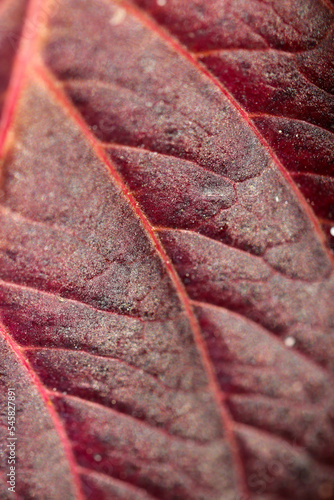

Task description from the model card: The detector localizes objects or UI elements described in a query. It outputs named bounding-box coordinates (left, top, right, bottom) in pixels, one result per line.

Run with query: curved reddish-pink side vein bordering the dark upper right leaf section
left=120, top=0, right=334, bottom=270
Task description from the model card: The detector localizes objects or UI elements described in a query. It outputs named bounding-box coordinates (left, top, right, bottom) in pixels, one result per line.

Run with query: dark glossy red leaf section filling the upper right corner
left=132, top=0, right=334, bottom=247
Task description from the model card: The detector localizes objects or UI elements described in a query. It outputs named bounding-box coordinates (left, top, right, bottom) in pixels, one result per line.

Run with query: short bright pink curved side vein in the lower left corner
left=0, top=323, right=84, bottom=500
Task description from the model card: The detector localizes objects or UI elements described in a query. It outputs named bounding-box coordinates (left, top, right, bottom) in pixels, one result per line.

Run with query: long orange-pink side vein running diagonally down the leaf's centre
left=35, top=64, right=249, bottom=499
